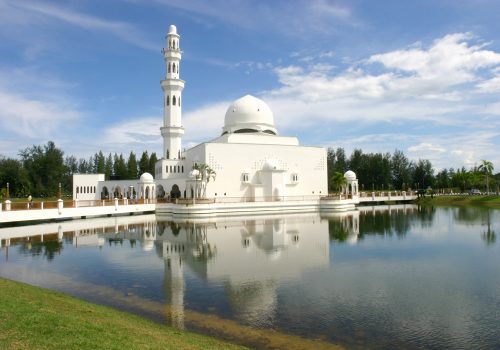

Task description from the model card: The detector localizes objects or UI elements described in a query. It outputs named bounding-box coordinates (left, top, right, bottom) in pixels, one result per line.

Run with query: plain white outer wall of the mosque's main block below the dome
left=185, top=139, right=328, bottom=198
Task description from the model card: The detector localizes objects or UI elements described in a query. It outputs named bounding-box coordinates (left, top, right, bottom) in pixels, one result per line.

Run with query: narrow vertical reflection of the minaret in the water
left=163, top=242, right=185, bottom=329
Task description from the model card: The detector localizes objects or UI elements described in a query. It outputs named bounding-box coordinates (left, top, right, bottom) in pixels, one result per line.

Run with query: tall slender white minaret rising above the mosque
left=160, top=25, right=184, bottom=159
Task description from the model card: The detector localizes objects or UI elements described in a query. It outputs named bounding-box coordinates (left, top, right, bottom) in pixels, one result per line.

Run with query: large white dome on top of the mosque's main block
left=222, top=95, right=278, bottom=135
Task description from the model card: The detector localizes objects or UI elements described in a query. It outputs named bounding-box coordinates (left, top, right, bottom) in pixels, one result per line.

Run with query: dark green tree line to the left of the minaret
left=0, top=141, right=158, bottom=198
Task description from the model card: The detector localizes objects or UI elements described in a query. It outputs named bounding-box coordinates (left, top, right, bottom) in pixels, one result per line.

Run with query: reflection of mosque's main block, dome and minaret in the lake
left=155, top=214, right=329, bottom=327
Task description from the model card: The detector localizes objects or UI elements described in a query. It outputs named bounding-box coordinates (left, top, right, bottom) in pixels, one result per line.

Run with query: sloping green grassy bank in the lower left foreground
left=0, top=278, right=241, bottom=349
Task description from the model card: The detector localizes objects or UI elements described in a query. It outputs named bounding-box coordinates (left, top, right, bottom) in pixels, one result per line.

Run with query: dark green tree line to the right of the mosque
left=327, top=147, right=500, bottom=192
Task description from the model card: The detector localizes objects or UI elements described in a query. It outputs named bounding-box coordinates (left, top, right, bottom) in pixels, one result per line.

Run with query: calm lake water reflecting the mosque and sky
left=0, top=205, right=500, bottom=349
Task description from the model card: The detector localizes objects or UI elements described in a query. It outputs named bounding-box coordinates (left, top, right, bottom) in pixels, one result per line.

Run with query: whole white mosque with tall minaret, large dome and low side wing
left=73, top=25, right=357, bottom=208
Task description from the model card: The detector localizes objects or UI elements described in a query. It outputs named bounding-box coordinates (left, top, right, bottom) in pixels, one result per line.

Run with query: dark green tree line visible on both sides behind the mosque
left=0, top=141, right=500, bottom=198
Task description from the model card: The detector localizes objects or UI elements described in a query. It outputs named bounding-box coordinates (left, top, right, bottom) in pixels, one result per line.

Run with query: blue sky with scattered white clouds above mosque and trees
left=0, top=0, right=500, bottom=172
